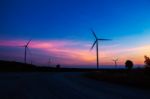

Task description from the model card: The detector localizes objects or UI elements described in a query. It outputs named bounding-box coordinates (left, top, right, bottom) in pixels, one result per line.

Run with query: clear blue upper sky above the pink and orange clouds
left=0, top=0, right=150, bottom=67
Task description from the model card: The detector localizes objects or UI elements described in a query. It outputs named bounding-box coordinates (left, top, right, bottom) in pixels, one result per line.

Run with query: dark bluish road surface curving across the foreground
left=0, top=72, right=150, bottom=99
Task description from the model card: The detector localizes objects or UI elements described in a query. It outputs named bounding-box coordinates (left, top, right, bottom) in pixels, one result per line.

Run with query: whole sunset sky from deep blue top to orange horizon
left=0, top=0, right=150, bottom=67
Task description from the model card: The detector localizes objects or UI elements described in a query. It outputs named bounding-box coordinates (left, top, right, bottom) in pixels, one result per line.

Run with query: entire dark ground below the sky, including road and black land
left=0, top=61, right=150, bottom=99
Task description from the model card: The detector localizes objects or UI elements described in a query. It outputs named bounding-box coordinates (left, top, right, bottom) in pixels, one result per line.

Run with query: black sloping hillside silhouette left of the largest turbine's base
left=0, top=60, right=99, bottom=72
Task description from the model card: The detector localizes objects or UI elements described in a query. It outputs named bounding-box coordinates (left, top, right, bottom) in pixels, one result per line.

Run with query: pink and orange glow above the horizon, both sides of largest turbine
left=0, top=40, right=150, bottom=65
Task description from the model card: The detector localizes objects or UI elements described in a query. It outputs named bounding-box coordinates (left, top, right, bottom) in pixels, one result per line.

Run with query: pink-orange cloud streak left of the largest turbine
left=0, top=40, right=94, bottom=65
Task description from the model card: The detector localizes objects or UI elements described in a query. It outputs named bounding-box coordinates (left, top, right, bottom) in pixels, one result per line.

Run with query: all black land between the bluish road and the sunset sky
left=0, top=61, right=150, bottom=90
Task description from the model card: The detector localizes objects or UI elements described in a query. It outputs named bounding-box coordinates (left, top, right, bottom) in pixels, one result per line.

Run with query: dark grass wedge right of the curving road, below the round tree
left=84, top=69, right=150, bottom=90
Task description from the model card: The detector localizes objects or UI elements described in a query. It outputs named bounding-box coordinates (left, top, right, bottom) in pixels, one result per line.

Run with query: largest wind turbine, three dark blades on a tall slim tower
left=91, top=29, right=111, bottom=69
